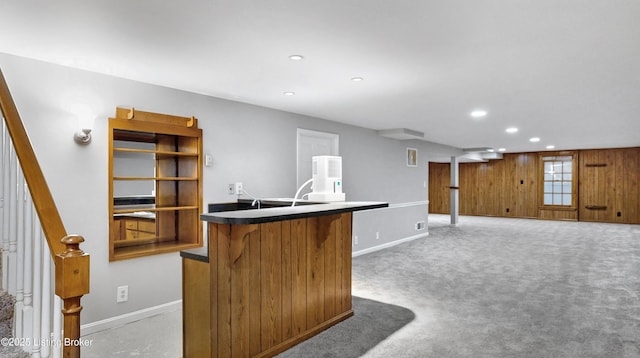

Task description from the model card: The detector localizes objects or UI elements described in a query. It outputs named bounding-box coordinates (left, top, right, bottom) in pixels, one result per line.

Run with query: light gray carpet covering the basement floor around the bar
left=83, top=215, right=640, bottom=358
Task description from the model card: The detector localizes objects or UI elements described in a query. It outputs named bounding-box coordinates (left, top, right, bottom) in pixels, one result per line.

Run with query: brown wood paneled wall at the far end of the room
left=429, top=148, right=640, bottom=224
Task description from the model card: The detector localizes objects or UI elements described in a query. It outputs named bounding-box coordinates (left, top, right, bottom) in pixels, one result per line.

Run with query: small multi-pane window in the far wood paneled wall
left=541, top=155, right=576, bottom=207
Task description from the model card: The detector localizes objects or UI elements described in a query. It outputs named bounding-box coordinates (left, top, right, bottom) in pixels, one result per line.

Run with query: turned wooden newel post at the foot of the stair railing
left=54, top=235, right=89, bottom=357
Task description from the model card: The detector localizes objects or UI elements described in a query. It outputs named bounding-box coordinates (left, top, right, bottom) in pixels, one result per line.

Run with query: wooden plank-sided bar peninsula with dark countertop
left=181, top=200, right=388, bottom=358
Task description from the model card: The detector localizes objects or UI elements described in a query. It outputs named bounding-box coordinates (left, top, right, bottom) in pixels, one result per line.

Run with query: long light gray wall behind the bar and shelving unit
left=0, top=54, right=459, bottom=324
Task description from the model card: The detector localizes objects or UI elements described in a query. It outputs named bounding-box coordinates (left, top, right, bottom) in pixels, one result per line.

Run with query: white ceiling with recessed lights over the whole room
left=0, top=0, right=640, bottom=152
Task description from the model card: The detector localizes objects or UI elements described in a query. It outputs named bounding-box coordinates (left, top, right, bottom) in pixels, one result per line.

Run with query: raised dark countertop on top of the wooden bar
left=200, top=201, right=389, bottom=225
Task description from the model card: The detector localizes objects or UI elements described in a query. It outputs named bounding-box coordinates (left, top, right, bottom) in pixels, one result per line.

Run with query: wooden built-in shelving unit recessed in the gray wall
left=109, top=108, right=203, bottom=261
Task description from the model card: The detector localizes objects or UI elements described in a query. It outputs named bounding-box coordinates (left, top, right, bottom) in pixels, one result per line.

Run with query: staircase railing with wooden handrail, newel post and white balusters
left=0, top=71, right=89, bottom=357
